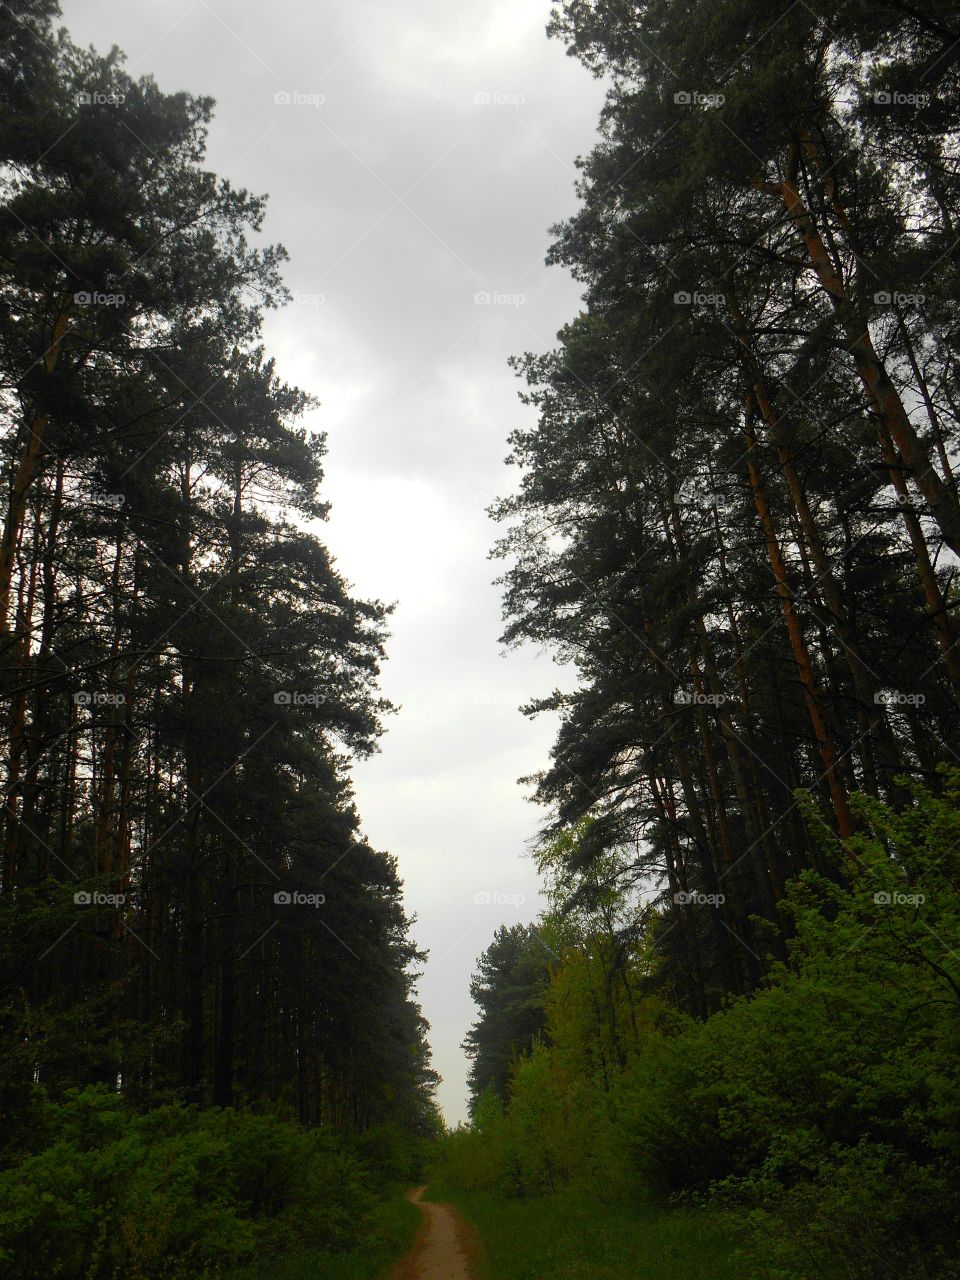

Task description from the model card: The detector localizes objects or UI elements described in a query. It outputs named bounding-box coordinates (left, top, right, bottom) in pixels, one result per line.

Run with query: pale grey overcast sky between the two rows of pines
left=63, top=0, right=602, bottom=1123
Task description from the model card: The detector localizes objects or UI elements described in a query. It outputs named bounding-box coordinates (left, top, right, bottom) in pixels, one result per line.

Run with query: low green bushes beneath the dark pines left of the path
left=0, top=1087, right=394, bottom=1280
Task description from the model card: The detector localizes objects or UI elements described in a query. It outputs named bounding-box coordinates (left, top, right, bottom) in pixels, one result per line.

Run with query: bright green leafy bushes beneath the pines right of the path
left=442, top=771, right=960, bottom=1280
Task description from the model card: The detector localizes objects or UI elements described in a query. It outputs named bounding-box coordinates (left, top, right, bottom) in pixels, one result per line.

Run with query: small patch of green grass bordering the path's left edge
left=236, top=1188, right=420, bottom=1280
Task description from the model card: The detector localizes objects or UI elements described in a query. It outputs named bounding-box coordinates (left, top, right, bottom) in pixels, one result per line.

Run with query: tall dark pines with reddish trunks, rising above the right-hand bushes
left=495, top=0, right=960, bottom=1016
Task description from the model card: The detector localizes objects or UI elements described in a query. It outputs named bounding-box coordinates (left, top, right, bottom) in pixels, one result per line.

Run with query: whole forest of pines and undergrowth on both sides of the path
left=0, top=0, right=960, bottom=1280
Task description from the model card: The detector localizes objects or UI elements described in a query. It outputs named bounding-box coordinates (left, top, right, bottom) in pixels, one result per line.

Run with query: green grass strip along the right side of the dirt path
left=428, top=1184, right=765, bottom=1280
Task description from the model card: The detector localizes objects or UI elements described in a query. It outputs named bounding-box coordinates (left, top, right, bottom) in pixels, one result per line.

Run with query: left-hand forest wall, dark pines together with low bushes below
left=0, top=0, right=436, bottom=1277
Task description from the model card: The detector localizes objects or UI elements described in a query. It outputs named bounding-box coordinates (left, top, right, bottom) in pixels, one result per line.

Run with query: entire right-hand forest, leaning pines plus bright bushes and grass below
left=438, top=0, right=960, bottom=1280
